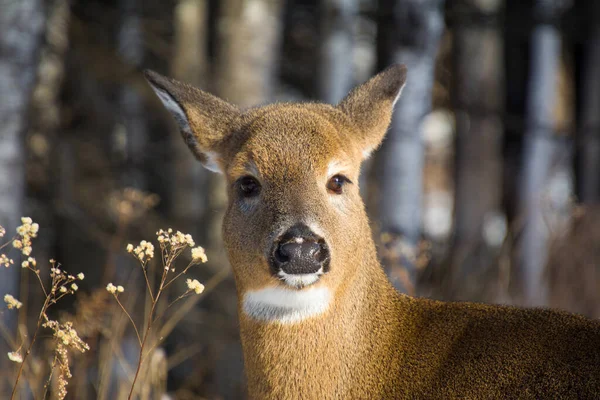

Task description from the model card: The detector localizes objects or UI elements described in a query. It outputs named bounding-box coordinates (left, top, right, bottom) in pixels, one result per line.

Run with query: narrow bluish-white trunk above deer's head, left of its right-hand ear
left=318, top=0, right=358, bottom=104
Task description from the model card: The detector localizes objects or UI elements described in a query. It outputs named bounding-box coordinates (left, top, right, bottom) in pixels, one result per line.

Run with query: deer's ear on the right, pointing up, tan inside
left=337, top=64, right=406, bottom=158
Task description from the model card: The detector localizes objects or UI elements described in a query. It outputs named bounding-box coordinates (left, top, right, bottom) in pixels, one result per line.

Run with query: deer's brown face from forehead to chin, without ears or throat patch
left=223, top=105, right=366, bottom=290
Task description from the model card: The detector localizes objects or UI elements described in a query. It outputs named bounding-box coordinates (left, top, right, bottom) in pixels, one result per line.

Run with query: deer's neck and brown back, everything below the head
left=240, top=239, right=600, bottom=399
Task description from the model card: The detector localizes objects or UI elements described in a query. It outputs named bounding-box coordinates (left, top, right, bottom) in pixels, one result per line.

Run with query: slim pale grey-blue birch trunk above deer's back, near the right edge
left=519, top=0, right=567, bottom=306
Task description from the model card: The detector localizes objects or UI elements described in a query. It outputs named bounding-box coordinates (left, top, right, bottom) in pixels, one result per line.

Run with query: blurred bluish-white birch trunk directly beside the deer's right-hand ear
left=375, top=0, right=444, bottom=293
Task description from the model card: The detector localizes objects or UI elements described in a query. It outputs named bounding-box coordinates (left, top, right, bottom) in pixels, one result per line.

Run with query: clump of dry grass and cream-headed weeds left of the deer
left=0, top=193, right=227, bottom=399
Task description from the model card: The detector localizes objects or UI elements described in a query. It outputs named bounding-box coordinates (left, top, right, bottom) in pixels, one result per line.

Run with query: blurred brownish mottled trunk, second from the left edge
left=24, top=0, right=71, bottom=354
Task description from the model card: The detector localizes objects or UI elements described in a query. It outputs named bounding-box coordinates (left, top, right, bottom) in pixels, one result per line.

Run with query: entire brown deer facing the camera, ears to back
left=145, top=65, right=600, bottom=399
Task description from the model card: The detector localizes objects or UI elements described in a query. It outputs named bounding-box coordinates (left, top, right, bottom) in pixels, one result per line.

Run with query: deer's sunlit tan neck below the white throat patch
left=240, top=245, right=403, bottom=399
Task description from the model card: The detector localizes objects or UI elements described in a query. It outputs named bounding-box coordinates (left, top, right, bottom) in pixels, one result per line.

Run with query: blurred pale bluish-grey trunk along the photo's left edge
left=0, top=0, right=44, bottom=334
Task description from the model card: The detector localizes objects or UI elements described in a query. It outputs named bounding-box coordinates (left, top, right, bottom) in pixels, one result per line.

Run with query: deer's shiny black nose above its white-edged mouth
left=271, top=224, right=329, bottom=274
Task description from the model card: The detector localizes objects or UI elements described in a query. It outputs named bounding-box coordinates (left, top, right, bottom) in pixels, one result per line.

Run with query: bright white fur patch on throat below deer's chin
left=242, top=286, right=331, bottom=324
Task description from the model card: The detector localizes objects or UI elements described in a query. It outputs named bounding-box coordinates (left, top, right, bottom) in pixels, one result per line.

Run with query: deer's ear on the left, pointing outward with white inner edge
left=144, top=70, right=240, bottom=172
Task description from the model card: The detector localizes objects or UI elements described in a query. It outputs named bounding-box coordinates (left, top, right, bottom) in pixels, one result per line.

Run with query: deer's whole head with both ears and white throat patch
left=148, top=66, right=405, bottom=322
